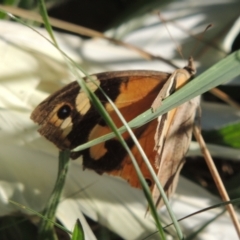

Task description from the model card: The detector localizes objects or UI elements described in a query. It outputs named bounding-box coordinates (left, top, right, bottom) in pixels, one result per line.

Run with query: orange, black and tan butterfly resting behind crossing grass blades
left=31, top=59, right=198, bottom=207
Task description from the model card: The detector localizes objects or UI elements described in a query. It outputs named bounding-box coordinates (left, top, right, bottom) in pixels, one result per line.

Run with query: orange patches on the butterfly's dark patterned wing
left=89, top=77, right=163, bottom=188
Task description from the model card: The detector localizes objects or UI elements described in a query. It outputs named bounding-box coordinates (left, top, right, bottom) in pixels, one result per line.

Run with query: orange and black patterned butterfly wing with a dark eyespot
left=31, top=71, right=169, bottom=187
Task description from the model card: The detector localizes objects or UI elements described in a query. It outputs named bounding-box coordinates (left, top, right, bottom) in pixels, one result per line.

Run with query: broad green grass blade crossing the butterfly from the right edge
left=73, top=50, right=240, bottom=151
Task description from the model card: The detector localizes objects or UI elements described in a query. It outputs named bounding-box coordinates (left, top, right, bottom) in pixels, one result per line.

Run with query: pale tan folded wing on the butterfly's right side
left=152, top=62, right=199, bottom=207
